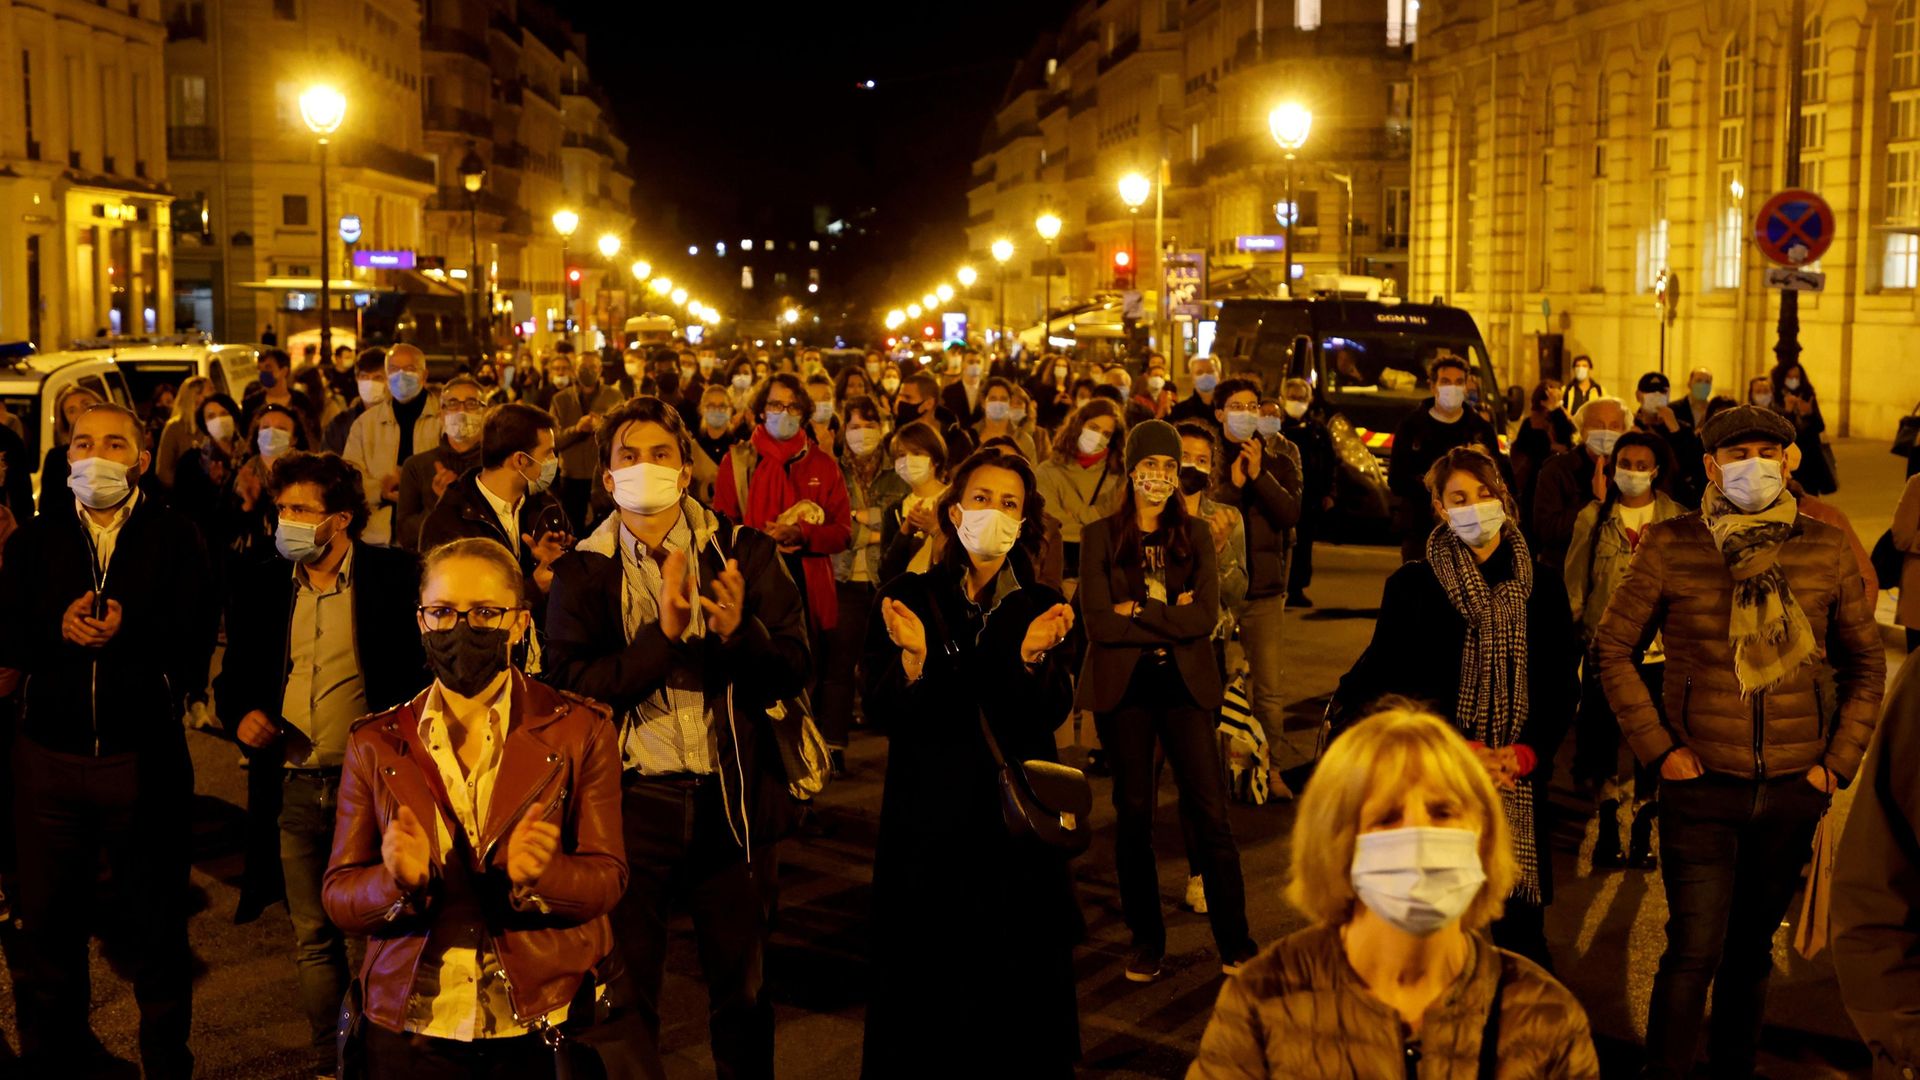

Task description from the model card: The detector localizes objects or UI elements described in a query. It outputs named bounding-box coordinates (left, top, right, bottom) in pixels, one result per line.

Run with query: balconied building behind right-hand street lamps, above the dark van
left=968, top=0, right=1417, bottom=345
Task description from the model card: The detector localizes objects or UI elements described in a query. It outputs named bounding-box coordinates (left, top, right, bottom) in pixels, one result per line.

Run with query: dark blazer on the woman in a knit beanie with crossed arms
left=1075, top=505, right=1221, bottom=713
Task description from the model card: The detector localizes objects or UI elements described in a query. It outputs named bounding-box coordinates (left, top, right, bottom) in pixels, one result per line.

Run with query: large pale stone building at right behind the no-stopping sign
left=1411, top=0, right=1920, bottom=436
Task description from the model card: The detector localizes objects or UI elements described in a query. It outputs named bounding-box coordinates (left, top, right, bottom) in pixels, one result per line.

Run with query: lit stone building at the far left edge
left=0, top=0, right=173, bottom=350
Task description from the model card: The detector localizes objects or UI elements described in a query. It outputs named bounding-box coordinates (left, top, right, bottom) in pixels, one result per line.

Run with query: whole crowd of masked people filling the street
left=0, top=330, right=1920, bottom=1078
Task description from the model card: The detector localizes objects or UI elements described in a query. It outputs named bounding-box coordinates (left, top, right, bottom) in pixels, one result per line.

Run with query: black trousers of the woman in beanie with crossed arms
left=1094, top=657, right=1252, bottom=959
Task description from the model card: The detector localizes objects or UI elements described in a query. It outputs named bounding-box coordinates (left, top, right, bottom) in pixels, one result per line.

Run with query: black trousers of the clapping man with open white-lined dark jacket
left=612, top=773, right=774, bottom=1080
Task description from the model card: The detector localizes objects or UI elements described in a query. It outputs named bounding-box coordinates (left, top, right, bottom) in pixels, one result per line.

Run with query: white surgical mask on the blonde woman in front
left=1348, top=826, right=1486, bottom=938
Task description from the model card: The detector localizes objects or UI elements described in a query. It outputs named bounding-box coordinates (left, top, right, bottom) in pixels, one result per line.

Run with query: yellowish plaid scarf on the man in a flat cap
left=1699, top=486, right=1814, bottom=698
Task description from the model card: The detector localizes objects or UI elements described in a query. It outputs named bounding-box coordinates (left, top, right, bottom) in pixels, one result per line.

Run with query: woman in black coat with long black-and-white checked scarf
left=1329, top=446, right=1578, bottom=970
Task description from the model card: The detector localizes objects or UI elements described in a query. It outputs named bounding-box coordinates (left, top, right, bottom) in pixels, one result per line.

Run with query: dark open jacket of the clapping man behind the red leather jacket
left=541, top=503, right=812, bottom=849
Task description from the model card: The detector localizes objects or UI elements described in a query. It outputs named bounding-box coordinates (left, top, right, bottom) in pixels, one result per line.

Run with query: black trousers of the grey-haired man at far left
left=10, top=717, right=194, bottom=1078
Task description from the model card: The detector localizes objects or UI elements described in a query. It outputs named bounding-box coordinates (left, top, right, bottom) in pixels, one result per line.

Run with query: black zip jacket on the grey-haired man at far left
left=0, top=494, right=219, bottom=755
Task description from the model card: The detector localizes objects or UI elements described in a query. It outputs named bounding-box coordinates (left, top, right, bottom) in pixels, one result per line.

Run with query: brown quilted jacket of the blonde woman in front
left=1187, top=926, right=1599, bottom=1080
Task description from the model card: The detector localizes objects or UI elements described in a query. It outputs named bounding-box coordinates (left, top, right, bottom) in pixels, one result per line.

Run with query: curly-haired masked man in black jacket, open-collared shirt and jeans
left=213, top=452, right=426, bottom=1072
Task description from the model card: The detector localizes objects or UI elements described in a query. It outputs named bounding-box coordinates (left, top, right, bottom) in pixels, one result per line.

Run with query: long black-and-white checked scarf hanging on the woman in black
left=1427, top=523, right=1540, bottom=905
